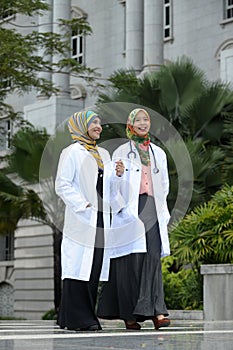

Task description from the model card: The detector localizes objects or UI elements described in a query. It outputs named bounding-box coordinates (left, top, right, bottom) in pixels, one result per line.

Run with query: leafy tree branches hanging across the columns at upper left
left=0, top=0, right=95, bottom=114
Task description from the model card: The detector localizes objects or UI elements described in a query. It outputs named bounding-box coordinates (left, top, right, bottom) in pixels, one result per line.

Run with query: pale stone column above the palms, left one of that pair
left=126, top=0, right=143, bottom=72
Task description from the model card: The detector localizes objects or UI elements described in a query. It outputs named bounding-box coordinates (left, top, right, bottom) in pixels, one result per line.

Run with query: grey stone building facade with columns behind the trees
left=0, top=0, right=233, bottom=318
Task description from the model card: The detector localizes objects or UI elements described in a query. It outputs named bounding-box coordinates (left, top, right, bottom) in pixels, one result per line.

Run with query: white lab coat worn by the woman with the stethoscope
left=110, top=142, right=170, bottom=258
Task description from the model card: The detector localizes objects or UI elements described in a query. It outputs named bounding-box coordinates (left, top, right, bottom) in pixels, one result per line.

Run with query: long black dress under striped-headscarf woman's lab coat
left=57, top=171, right=104, bottom=330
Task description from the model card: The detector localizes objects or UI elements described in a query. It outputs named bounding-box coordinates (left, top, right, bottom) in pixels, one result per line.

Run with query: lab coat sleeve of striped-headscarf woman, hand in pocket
left=55, top=150, right=89, bottom=212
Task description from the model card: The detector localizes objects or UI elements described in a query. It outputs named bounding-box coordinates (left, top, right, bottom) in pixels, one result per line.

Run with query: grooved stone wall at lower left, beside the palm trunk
left=14, top=220, right=54, bottom=319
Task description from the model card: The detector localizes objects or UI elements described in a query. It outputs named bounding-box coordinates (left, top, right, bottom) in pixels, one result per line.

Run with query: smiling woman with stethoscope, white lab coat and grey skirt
left=97, top=109, right=170, bottom=330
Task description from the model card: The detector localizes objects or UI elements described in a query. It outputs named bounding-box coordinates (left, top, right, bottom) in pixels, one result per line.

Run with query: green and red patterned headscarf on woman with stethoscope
left=126, top=108, right=150, bottom=166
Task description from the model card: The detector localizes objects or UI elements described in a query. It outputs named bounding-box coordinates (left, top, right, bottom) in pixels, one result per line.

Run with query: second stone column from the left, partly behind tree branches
left=53, top=0, right=71, bottom=97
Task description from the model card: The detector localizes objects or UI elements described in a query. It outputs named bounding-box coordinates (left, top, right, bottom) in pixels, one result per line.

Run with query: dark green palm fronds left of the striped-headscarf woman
left=0, top=126, right=51, bottom=234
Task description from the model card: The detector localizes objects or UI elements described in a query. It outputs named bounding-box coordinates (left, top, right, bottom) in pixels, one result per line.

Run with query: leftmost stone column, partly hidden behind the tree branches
left=37, top=0, right=53, bottom=100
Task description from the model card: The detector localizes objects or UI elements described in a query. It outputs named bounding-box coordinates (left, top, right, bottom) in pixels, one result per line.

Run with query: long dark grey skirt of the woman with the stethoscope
left=97, top=194, right=168, bottom=322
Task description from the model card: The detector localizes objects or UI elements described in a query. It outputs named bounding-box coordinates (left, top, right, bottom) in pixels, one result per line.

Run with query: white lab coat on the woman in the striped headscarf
left=55, top=142, right=111, bottom=281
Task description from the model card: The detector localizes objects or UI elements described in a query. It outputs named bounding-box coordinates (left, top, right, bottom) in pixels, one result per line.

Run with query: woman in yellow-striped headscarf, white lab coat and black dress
left=55, top=111, right=110, bottom=331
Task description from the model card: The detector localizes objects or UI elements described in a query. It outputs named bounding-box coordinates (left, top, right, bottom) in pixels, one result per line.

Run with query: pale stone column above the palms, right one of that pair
left=143, top=0, right=163, bottom=73
